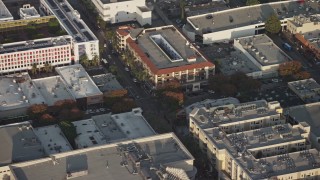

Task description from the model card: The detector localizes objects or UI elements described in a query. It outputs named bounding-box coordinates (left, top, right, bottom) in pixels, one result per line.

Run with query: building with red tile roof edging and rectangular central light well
left=122, top=25, right=215, bottom=91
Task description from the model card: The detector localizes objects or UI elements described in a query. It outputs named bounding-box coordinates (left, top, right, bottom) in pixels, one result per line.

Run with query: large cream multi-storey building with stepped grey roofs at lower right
left=189, top=100, right=320, bottom=180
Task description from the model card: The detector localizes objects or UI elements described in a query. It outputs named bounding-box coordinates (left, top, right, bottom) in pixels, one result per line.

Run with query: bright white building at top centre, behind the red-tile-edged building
left=92, top=0, right=152, bottom=26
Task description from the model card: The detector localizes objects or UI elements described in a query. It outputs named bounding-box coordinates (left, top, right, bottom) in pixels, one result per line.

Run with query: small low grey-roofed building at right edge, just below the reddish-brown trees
left=288, top=78, right=320, bottom=103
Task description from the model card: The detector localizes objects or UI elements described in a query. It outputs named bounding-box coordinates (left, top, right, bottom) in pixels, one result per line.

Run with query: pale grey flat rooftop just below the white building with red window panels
left=56, top=64, right=102, bottom=99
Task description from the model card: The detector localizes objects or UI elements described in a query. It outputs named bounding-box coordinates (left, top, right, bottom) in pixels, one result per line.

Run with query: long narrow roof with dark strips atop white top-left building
left=45, top=0, right=98, bottom=42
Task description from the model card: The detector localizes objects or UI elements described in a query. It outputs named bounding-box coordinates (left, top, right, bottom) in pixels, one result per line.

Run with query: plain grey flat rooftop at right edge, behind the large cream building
left=288, top=102, right=320, bottom=137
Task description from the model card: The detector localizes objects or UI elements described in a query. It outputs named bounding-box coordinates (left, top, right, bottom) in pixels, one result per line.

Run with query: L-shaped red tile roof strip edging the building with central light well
left=126, top=38, right=214, bottom=75
